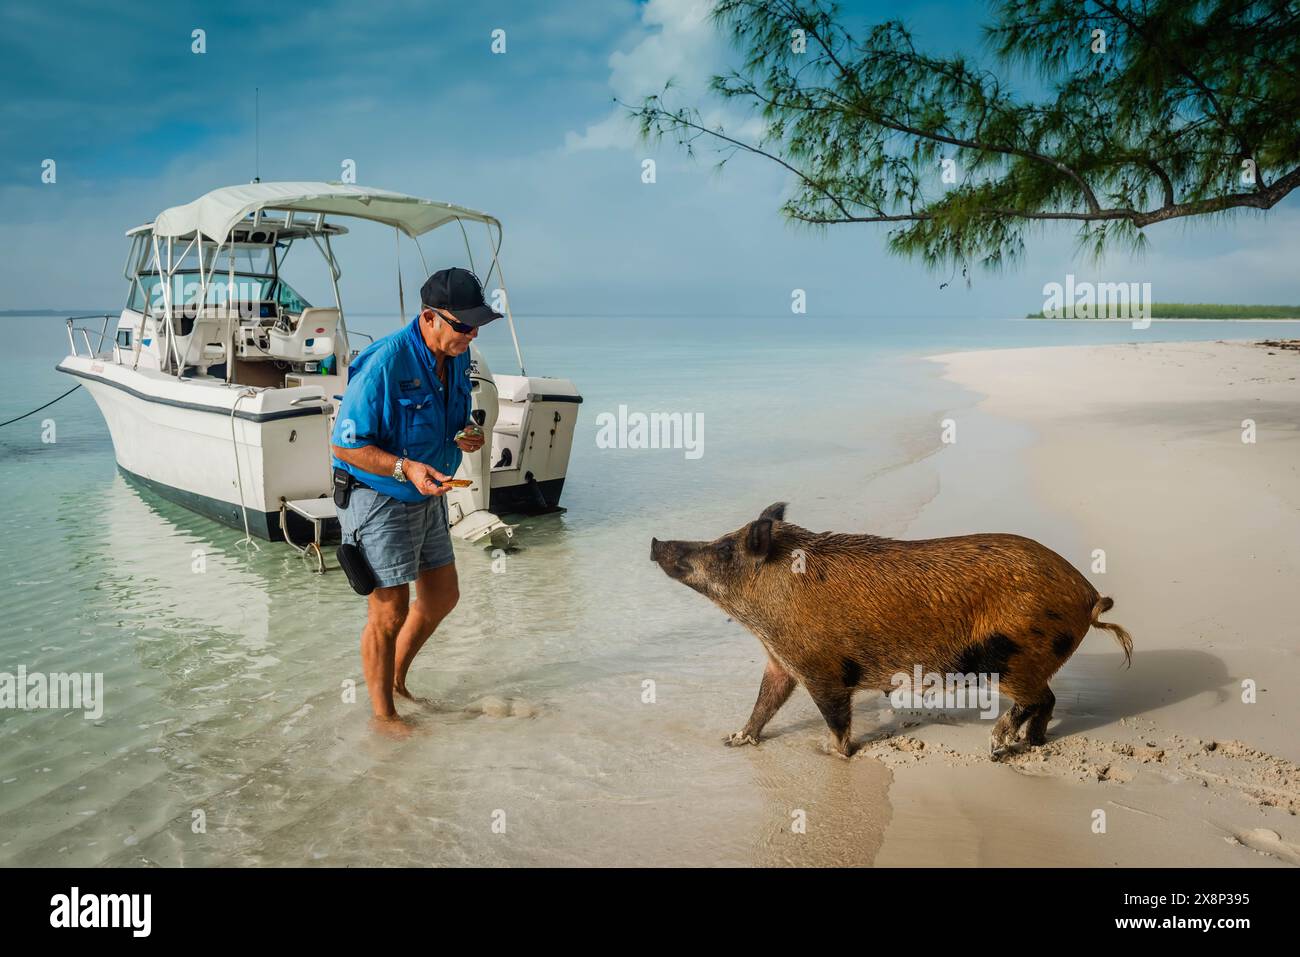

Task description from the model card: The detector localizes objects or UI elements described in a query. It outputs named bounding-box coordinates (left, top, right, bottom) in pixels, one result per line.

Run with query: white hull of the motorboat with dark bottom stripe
left=57, top=356, right=582, bottom=544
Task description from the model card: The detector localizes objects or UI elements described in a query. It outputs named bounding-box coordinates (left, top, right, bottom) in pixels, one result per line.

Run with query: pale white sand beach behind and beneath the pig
left=858, top=342, right=1300, bottom=866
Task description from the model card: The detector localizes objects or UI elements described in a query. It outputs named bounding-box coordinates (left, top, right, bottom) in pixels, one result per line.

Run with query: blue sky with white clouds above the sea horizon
left=0, top=0, right=1300, bottom=321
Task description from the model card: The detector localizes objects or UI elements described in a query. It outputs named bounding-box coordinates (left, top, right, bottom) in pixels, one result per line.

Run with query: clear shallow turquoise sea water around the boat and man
left=0, top=317, right=1300, bottom=865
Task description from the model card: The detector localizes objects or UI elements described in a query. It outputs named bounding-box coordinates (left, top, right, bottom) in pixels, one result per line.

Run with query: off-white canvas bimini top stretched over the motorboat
left=148, top=183, right=501, bottom=242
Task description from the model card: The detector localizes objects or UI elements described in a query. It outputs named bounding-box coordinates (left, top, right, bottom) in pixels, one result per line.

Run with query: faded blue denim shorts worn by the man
left=338, top=488, right=456, bottom=588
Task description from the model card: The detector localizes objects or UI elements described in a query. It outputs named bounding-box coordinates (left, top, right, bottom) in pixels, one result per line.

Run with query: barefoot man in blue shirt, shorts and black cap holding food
left=332, top=269, right=501, bottom=727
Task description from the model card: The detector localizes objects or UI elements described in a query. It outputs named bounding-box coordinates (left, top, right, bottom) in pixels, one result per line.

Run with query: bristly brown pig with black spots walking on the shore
left=650, top=502, right=1132, bottom=757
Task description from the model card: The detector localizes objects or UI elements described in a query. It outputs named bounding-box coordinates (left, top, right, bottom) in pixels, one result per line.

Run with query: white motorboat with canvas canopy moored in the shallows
left=57, top=182, right=582, bottom=568
